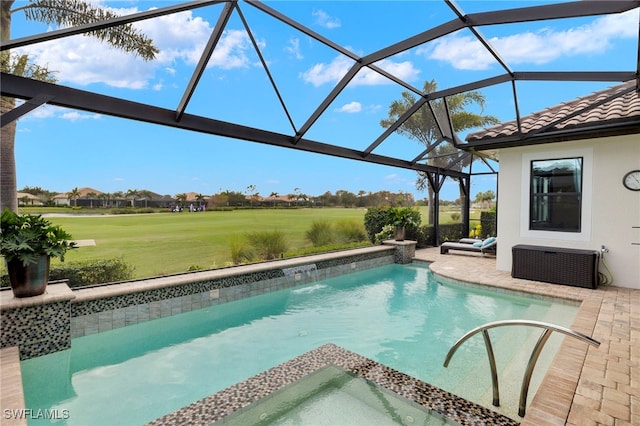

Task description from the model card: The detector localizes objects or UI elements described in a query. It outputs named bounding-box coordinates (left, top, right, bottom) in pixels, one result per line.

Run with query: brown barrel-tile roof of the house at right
left=466, top=80, right=640, bottom=148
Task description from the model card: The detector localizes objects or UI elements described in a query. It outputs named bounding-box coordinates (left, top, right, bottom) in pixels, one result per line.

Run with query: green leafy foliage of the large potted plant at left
left=0, top=209, right=76, bottom=266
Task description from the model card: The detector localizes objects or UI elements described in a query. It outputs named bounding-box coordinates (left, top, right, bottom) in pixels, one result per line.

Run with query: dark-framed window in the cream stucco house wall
left=529, top=157, right=583, bottom=232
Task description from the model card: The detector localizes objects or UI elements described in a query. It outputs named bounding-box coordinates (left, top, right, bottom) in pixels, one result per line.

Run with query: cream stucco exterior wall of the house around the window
left=497, top=135, right=640, bottom=288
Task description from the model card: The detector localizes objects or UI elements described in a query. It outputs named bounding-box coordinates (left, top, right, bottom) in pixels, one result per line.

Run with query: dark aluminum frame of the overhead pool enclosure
left=0, top=0, right=640, bottom=243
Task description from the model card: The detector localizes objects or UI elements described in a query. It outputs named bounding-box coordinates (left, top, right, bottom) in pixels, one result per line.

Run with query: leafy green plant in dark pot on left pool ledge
left=0, top=209, right=76, bottom=297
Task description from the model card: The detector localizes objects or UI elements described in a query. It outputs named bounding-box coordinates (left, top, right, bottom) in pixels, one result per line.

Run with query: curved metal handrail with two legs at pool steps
left=444, top=320, right=600, bottom=417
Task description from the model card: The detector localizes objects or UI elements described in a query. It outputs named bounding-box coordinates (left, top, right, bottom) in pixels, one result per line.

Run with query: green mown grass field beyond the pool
left=5, top=207, right=479, bottom=278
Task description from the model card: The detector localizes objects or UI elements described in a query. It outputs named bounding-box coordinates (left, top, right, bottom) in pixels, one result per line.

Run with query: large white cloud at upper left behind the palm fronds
left=21, top=9, right=253, bottom=89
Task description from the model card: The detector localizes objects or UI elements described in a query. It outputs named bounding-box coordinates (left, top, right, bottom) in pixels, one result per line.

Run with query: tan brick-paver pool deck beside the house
left=416, top=248, right=640, bottom=426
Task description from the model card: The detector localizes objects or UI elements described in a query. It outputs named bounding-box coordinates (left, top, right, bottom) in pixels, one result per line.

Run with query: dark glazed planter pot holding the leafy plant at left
left=7, top=255, right=50, bottom=297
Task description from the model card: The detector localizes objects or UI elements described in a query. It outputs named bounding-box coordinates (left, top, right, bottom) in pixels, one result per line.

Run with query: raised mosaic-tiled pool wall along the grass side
left=0, top=249, right=394, bottom=360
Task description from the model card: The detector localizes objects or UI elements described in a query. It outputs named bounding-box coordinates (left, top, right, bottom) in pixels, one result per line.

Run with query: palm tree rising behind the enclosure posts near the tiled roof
left=380, top=80, right=499, bottom=223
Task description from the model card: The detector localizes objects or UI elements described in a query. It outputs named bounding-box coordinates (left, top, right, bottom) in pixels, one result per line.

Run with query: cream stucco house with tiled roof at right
left=466, top=81, right=640, bottom=289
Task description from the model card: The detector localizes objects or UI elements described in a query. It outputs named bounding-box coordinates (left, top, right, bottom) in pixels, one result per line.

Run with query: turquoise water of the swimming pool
left=21, top=265, right=577, bottom=425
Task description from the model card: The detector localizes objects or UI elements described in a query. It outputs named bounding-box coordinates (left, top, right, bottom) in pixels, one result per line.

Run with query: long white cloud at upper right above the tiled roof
left=418, top=10, right=638, bottom=70
